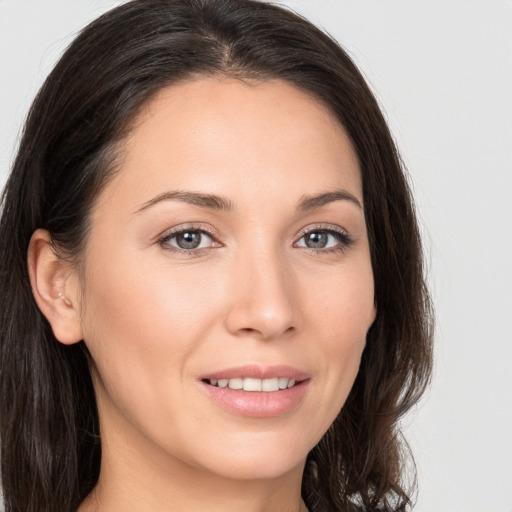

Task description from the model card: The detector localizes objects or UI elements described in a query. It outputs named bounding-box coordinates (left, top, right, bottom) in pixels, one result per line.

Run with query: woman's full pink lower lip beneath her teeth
left=201, top=380, right=309, bottom=418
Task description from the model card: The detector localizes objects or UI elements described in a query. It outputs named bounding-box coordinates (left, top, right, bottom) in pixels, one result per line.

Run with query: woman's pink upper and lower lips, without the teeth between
left=201, top=365, right=310, bottom=418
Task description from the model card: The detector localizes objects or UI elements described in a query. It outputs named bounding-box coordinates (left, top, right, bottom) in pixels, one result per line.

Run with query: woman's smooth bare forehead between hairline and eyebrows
left=94, top=78, right=362, bottom=216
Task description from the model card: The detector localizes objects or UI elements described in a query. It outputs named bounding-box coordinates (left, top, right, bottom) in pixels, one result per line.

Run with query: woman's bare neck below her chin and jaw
left=78, top=400, right=307, bottom=512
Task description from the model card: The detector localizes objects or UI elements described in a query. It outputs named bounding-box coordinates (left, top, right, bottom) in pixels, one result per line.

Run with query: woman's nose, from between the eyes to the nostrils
left=226, top=247, right=299, bottom=340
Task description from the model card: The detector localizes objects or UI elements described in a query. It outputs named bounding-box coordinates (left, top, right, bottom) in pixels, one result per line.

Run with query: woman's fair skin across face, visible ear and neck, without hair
left=29, top=78, right=375, bottom=512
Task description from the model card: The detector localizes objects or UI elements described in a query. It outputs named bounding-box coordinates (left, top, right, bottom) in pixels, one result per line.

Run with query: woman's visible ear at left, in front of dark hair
left=27, top=229, right=82, bottom=345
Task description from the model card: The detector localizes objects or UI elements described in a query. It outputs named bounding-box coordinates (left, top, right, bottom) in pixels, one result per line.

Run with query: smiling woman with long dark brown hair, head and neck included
left=0, top=0, right=431, bottom=512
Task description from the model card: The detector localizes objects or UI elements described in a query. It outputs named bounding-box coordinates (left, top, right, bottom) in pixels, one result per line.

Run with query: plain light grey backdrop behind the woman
left=0, top=0, right=512, bottom=512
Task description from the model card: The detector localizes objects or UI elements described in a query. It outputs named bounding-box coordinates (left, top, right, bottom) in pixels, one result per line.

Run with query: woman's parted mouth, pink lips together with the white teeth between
left=201, top=365, right=310, bottom=418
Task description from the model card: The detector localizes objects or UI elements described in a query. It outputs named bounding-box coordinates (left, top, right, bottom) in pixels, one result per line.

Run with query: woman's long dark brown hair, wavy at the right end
left=0, top=0, right=432, bottom=512
